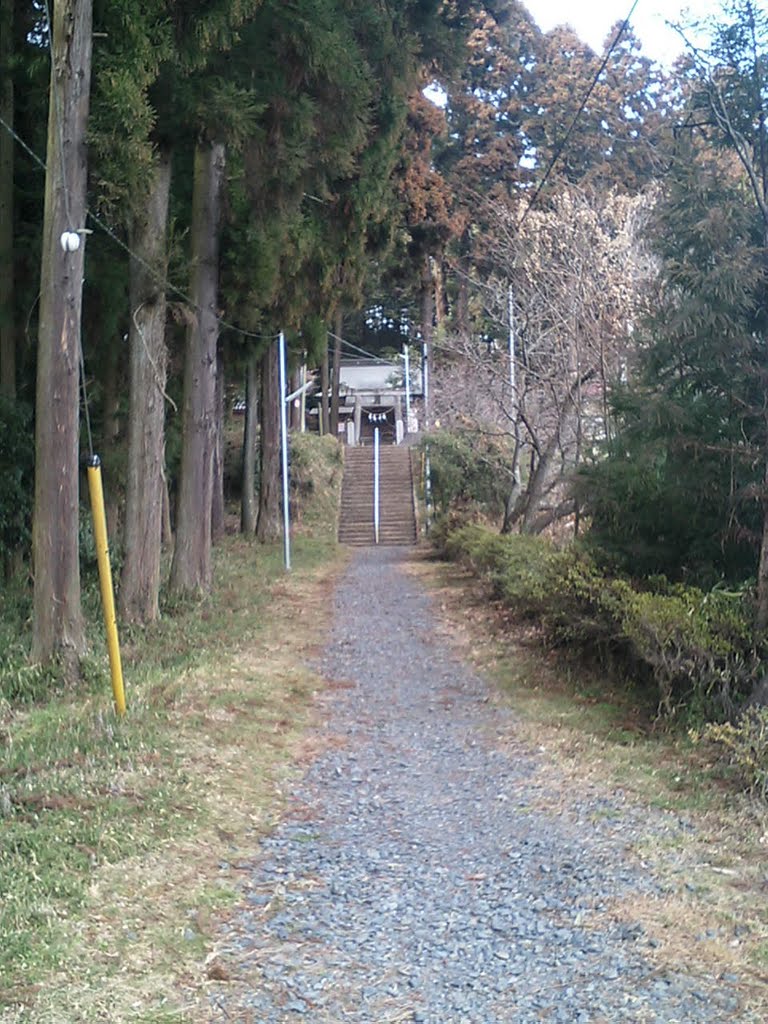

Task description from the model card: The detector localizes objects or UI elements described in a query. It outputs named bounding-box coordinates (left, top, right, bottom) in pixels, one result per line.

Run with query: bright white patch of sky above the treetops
left=523, top=0, right=719, bottom=65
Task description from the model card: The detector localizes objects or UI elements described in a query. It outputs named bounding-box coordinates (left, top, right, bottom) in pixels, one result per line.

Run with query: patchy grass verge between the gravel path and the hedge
left=412, top=556, right=768, bottom=1020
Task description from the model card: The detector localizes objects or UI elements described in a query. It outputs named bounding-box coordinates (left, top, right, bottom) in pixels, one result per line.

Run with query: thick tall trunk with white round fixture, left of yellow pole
left=32, top=0, right=92, bottom=675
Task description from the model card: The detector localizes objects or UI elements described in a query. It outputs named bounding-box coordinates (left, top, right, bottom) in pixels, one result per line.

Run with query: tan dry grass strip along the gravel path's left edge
left=0, top=558, right=348, bottom=1024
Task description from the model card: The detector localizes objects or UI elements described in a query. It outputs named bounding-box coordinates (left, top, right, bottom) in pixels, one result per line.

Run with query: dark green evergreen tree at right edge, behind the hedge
left=578, top=140, right=768, bottom=585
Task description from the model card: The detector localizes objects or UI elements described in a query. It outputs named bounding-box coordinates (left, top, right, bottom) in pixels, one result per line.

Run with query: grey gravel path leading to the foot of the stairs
left=211, top=549, right=752, bottom=1024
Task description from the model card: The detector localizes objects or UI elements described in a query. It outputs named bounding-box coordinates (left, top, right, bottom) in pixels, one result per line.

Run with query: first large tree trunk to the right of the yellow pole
left=120, top=154, right=171, bottom=623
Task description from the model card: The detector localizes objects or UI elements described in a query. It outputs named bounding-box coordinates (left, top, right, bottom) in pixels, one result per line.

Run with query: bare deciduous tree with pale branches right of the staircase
left=435, top=187, right=652, bottom=532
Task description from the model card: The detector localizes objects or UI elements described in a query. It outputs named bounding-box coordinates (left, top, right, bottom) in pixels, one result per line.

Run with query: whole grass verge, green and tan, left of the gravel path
left=0, top=537, right=342, bottom=1024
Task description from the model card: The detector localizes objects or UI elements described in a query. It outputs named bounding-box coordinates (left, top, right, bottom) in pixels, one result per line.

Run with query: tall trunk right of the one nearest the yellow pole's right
left=170, top=142, right=224, bottom=594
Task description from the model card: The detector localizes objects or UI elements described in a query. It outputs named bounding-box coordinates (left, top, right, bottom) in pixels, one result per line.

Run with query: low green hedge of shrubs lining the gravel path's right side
left=433, top=524, right=764, bottom=721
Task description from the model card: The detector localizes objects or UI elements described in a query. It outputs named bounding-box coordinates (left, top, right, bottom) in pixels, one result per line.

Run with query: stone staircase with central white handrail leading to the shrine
left=339, top=444, right=417, bottom=546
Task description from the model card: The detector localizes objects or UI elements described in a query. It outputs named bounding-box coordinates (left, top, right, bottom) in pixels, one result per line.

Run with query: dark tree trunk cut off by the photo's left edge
left=0, top=0, right=16, bottom=401
